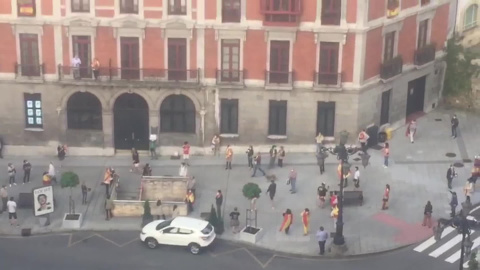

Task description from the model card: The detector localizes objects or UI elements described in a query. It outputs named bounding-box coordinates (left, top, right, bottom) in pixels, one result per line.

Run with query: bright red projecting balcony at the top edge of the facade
left=260, top=0, right=302, bottom=26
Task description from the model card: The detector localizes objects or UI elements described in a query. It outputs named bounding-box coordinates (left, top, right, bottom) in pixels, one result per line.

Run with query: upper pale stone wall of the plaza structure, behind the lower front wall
left=141, top=176, right=188, bottom=202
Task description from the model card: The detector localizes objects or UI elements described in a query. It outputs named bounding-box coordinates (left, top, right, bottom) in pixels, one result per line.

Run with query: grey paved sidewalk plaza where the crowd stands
left=0, top=106, right=480, bottom=255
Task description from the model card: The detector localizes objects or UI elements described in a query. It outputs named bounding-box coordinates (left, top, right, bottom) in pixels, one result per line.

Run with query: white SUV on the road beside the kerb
left=140, top=217, right=216, bottom=255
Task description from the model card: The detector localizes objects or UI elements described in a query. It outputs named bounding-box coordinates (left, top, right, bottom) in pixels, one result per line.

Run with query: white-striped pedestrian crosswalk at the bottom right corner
left=413, top=227, right=480, bottom=267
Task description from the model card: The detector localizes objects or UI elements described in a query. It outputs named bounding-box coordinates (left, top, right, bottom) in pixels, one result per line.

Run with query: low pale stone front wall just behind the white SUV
left=112, top=200, right=188, bottom=217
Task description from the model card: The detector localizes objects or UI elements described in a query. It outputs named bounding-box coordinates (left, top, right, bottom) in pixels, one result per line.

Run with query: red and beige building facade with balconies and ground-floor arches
left=0, top=0, right=452, bottom=155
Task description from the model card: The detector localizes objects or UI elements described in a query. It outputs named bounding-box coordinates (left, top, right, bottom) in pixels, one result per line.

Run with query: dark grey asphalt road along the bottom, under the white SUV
left=0, top=232, right=455, bottom=270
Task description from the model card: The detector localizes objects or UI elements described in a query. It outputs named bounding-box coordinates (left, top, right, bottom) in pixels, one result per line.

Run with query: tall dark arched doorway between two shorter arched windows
left=113, top=93, right=149, bottom=150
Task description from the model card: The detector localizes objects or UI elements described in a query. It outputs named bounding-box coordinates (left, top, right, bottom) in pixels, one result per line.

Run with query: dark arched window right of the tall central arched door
left=160, top=95, right=195, bottom=133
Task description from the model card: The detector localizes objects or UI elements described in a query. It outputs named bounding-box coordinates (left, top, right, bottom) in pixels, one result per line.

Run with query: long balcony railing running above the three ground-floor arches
left=58, top=65, right=200, bottom=84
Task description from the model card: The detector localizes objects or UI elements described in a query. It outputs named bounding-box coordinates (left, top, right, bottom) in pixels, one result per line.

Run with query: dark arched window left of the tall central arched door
left=67, top=92, right=103, bottom=130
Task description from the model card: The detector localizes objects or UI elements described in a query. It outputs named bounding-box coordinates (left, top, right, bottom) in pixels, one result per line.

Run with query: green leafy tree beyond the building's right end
left=444, top=37, right=479, bottom=96
